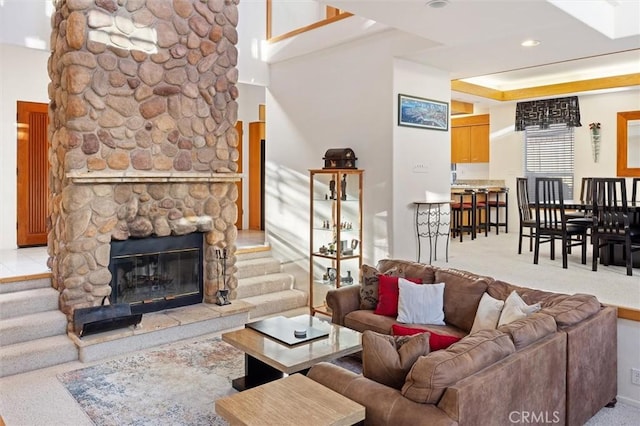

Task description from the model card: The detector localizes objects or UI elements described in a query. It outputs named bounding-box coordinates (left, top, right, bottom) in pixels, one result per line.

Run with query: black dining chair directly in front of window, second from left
left=533, top=177, right=589, bottom=269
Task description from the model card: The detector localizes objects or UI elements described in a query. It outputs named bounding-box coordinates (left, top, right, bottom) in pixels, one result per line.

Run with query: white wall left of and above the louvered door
left=0, top=44, right=49, bottom=249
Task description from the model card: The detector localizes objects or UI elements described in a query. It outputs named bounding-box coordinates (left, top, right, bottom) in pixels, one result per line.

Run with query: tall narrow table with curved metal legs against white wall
left=413, top=200, right=451, bottom=264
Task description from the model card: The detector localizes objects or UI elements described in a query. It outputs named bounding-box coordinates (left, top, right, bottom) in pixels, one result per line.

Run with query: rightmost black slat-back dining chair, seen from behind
left=591, top=178, right=640, bottom=276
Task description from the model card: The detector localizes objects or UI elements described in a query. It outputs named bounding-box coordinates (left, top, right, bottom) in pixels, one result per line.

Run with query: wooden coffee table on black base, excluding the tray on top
left=222, top=315, right=362, bottom=391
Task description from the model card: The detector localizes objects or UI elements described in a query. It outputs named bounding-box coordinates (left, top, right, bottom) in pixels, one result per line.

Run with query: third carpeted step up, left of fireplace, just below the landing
left=0, top=287, right=58, bottom=319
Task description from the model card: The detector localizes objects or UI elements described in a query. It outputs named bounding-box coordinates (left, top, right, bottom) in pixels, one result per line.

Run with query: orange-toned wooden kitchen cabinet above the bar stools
left=451, top=114, right=489, bottom=163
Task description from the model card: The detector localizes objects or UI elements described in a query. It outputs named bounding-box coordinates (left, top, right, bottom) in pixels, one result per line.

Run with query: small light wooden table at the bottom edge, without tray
left=216, top=374, right=365, bottom=426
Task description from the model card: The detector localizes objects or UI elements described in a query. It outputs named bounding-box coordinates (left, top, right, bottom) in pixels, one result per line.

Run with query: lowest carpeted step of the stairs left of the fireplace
left=0, top=335, right=78, bottom=377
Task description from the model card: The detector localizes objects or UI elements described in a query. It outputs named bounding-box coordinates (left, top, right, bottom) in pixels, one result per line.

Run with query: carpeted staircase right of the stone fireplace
left=236, top=247, right=307, bottom=319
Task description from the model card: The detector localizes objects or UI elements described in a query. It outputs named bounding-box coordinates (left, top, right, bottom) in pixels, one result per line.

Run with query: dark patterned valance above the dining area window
left=516, top=96, right=582, bottom=131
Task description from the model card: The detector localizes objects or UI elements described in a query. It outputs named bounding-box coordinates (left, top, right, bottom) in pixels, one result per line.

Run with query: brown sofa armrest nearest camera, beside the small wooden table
left=307, top=362, right=457, bottom=426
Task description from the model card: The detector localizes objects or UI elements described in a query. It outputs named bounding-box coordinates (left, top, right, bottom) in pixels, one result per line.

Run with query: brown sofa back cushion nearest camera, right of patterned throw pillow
left=402, top=330, right=515, bottom=404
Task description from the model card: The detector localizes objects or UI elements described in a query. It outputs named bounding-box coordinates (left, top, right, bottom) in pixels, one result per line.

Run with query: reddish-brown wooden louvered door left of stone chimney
left=17, top=101, right=49, bottom=247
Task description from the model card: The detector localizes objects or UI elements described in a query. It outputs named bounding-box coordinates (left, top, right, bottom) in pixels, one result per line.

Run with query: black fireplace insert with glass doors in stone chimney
left=109, top=232, right=203, bottom=313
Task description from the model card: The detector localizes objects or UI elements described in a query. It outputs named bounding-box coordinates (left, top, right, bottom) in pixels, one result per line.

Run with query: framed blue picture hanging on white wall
left=398, top=94, right=449, bottom=131
